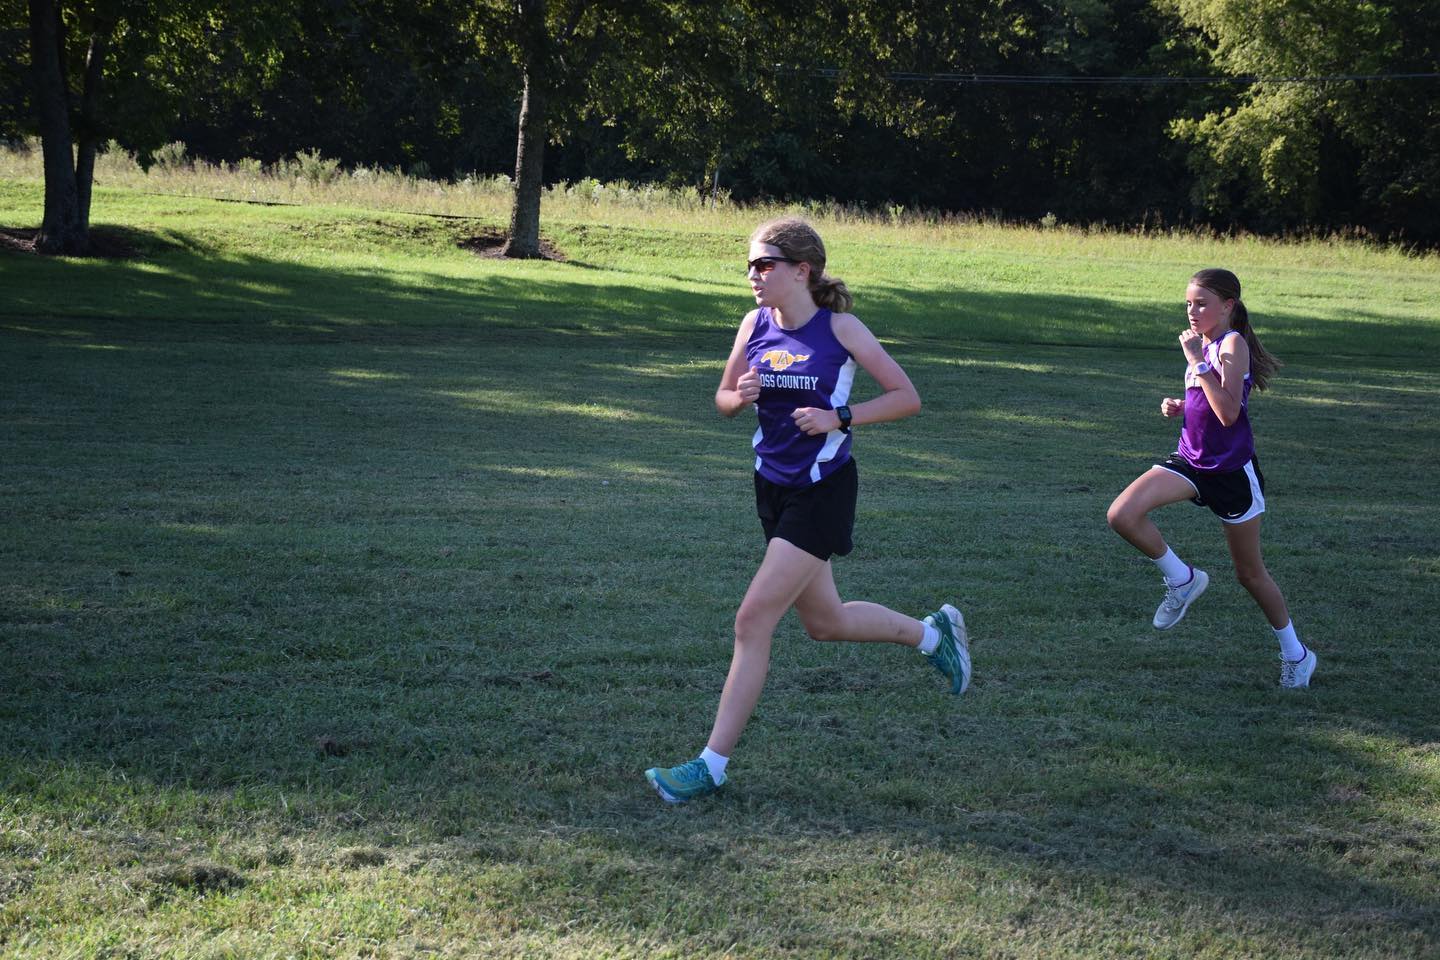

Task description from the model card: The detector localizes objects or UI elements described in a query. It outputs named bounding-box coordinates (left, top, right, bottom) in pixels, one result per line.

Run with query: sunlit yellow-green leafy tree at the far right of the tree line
left=1165, top=0, right=1440, bottom=242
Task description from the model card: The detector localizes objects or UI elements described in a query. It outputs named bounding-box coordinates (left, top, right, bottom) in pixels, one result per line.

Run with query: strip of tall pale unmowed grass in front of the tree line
left=0, top=141, right=1440, bottom=269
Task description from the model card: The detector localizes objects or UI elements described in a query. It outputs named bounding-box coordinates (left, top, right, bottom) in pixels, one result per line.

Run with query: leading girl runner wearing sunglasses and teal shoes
left=645, top=217, right=971, bottom=803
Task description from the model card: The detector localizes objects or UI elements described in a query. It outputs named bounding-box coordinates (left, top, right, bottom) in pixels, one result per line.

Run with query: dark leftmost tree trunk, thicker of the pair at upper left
left=30, top=0, right=89, bottom=255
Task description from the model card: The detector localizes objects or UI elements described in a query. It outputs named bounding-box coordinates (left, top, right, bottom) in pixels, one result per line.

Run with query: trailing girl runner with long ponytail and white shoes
left=1107, top=269, right=1316, bottom=688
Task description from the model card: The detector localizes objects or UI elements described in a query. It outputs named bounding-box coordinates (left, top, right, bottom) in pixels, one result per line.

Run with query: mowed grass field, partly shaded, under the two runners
left=0, top=181, right=1440, bottom=959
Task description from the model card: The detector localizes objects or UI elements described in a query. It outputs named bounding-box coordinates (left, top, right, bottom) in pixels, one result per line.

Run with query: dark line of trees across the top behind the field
left=0, top=0, right=1440, bottom=256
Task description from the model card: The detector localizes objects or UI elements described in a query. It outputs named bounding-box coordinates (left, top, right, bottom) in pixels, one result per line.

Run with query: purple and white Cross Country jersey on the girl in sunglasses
left=744, top=307, right=855, bottom=486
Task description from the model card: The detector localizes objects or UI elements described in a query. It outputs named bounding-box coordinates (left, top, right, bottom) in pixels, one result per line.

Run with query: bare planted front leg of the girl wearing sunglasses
left=707, top=537, right=829, bottom=757
